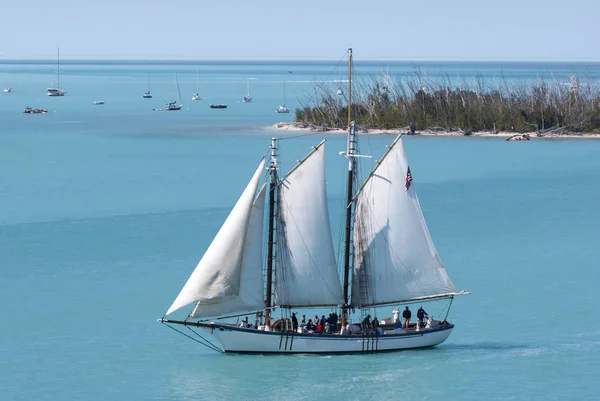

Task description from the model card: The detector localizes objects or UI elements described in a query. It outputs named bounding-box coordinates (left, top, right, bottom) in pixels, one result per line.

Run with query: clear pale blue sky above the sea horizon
left=0, top=0, right=600, bottom=61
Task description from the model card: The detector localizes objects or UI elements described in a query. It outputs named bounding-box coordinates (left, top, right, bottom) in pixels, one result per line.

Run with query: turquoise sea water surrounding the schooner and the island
left=0, top=62, right=600, bottom=401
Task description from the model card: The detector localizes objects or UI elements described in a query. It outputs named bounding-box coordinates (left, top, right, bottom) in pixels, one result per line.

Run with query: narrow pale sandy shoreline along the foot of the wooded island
left=269, top=122, right=600, bottom=141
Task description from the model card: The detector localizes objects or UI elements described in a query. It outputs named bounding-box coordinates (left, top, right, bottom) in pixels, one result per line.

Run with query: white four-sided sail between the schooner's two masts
left=275, top=142, right=343, bottom=306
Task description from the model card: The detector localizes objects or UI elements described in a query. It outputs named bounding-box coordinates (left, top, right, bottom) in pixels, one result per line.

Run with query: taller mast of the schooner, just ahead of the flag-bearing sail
left=342, top=48, right=356, bottom=327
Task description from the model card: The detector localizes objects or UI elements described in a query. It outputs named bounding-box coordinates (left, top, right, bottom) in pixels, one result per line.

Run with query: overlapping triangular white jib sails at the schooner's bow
left=167, top=159, right=265, bottom=318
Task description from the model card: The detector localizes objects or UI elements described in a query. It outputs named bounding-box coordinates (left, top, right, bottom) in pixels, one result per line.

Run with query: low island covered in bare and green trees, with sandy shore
left=278, top=74, right=600, bottom=140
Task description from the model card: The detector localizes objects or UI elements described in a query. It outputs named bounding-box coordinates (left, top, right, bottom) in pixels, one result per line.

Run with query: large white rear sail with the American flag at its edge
left=352, top=137, right=456, bottom=306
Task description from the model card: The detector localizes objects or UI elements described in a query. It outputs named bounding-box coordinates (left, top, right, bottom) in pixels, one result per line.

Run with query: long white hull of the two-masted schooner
left=200, top=324, right=454, bottom=354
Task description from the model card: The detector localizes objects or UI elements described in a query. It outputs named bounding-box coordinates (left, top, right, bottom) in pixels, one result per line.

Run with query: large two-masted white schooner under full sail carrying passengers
left=159, top=49, right=465, bottom=353
